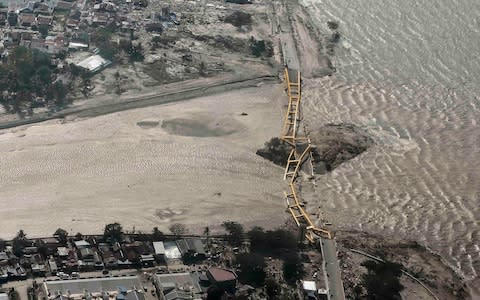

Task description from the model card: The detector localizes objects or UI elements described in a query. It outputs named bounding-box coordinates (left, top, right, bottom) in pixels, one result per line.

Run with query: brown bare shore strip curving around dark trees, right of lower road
left=336, top=229, right=474, bottom=299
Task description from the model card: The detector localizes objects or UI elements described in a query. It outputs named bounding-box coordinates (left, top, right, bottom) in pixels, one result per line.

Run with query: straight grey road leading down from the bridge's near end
left=320, top=238, right=345, bottom=300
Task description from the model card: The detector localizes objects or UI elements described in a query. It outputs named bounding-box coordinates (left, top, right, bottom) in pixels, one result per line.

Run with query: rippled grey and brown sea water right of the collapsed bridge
left=300, top=0, right=480, bottom=289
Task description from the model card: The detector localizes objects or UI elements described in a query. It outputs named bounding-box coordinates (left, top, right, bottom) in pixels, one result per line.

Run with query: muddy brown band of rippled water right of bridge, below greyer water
left=304, top=79, right=480, bottom=292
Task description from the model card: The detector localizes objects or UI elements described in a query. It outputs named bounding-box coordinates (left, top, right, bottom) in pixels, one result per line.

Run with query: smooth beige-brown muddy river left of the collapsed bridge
left=0, top=85, right=286, bottom=238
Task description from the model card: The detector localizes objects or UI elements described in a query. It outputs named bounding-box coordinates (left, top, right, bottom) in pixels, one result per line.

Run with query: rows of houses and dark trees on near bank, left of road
left=0, top=222, right=332, bottom=300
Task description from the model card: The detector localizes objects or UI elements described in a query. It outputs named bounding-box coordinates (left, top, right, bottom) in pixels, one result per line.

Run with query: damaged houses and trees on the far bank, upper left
left=0, top=0, right=273, bottom=117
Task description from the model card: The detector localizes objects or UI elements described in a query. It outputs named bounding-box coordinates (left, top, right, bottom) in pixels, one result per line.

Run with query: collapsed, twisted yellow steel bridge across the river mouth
left=281, top=68, right=332, bottom=242
